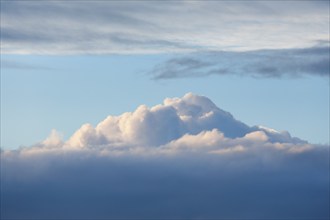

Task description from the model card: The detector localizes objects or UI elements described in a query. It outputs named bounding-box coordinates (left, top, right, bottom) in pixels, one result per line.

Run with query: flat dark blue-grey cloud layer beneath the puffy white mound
left=1, top=148, right=329, bottom=219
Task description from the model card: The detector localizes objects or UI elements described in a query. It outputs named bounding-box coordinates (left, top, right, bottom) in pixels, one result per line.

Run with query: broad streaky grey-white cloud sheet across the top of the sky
left=1, top=1, right=329, bottom=54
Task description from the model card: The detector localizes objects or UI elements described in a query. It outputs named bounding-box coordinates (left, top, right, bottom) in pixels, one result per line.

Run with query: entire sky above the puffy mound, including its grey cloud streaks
left=1, top=1, right=329, bottom=148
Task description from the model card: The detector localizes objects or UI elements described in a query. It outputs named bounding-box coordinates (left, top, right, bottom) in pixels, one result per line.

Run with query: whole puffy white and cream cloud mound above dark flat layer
left=15, top=93, right=312, bottom=155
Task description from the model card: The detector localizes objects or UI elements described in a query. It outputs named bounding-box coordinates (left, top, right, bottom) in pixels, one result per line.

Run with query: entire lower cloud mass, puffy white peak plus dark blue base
left=1, top=93, right=329, bottom=218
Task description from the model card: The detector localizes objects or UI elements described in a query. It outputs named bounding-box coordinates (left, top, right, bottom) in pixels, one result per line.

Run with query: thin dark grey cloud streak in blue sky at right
left=150, top=46, right=330, bottom=79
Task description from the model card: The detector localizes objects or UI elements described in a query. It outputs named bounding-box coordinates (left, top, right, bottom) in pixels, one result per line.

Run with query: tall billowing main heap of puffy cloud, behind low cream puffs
left=87, top=93, right=249, bottom=147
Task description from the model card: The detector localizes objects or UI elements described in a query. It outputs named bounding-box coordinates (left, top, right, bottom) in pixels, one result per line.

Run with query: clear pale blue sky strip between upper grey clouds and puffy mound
left=1, top=54, right=329, bottom=148
